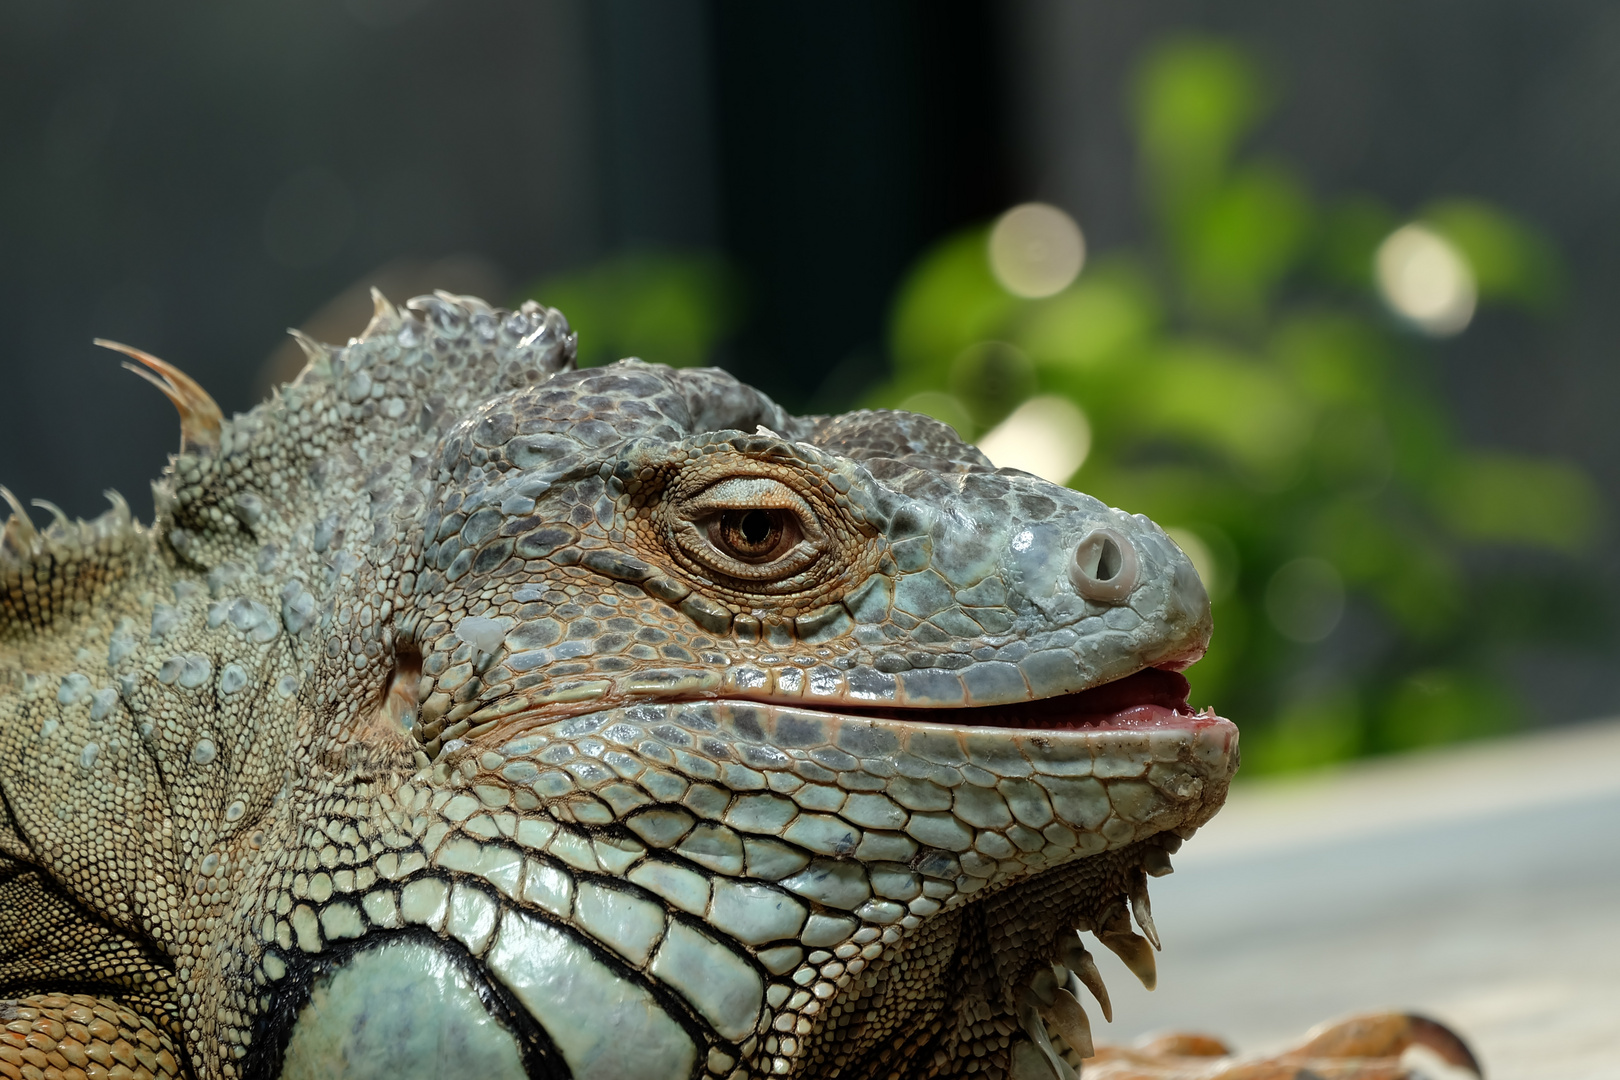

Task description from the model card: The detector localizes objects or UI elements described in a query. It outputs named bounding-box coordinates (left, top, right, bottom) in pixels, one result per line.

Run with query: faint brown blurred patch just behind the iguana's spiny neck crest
left=254, top=254, right=505, bottom=402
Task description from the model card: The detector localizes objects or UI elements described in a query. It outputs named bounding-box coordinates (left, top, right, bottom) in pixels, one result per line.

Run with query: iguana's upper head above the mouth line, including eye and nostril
left=397, top=369, right=1210, bottom=758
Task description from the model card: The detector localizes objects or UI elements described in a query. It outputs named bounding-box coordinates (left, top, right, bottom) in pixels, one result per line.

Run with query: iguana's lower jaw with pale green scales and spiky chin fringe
left=436, top=699, right=1238, bottom=1075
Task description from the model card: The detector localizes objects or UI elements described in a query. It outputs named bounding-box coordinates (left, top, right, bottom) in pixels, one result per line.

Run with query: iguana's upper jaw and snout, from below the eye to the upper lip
left=405, top=440, right=1210, bottom=758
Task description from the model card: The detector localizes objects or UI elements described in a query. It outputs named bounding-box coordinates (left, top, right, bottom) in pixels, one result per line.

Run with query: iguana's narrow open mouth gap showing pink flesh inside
left=838, top=667, right=1217, bottom=730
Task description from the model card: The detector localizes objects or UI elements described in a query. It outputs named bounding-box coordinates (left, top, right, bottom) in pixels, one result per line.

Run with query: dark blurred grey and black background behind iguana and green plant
left=0, top=0, right=1620, bottom=766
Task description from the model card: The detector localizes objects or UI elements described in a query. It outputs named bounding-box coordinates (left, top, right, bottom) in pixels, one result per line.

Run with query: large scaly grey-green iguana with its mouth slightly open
left=0, top=293, right=1477, bottom=1080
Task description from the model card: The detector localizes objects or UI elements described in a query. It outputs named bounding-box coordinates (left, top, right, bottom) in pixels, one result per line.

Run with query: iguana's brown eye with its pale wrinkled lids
left=676, top=476, right=825, bottom=585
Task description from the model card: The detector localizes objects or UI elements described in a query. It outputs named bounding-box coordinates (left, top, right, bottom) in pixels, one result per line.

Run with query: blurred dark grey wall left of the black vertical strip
left=0, top=0, right=608, bottom=517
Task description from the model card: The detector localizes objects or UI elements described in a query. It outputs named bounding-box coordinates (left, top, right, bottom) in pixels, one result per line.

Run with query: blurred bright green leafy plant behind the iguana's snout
left=865, top=40, right=1602, bottom=772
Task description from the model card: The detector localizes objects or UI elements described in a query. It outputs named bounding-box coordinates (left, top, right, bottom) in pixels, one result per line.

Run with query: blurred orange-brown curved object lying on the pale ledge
left=1082, top=1012, right=1482, bottom=1080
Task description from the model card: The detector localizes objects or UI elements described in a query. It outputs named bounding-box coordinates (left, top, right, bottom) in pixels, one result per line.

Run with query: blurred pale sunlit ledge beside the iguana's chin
left=1097, top=717, right=1620, bottom=1080
